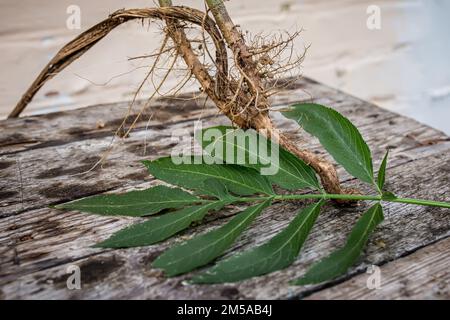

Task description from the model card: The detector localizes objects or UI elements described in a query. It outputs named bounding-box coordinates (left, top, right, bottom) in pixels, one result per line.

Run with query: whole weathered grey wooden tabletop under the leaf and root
left=0, top=79, right=450, bottom=299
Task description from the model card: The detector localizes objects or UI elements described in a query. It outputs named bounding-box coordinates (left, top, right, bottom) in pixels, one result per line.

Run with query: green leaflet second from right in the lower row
left=191, top=200, right=324, bottom=283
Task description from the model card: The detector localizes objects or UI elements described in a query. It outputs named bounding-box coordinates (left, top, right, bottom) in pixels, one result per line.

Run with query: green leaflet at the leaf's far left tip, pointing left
left=55, top=186, right=202, bottom=217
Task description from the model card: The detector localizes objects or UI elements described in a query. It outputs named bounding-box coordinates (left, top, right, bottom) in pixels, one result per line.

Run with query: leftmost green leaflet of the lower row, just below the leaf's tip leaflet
left=96, top=201, right=226, bottom=248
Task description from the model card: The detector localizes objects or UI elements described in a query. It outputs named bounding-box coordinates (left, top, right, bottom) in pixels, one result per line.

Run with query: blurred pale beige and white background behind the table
left=0, top=0, right=450, bottom=134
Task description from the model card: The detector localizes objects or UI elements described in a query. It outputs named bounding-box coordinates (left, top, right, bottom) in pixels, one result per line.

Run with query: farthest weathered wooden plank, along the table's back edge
left=0, top=78, right=384, bottom=155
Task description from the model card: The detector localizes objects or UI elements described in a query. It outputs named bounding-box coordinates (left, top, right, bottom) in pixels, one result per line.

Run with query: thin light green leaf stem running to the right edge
left=236, top=193, right=450, bottom=209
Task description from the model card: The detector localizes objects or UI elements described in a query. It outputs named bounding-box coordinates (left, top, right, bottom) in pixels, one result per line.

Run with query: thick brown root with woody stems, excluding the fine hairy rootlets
left=9, top=4, right=345, bottom=194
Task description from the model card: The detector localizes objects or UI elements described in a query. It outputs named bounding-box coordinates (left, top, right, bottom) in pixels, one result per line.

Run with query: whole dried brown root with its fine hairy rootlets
left=9, top=0, right=344, bottom=194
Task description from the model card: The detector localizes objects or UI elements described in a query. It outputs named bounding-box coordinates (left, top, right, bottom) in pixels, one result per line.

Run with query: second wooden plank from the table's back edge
left=0, top=86, right=450, bottom=217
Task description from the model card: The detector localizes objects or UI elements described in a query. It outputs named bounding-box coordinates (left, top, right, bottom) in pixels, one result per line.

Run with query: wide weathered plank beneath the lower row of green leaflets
left=0, top=152, right=450, bottom=299
